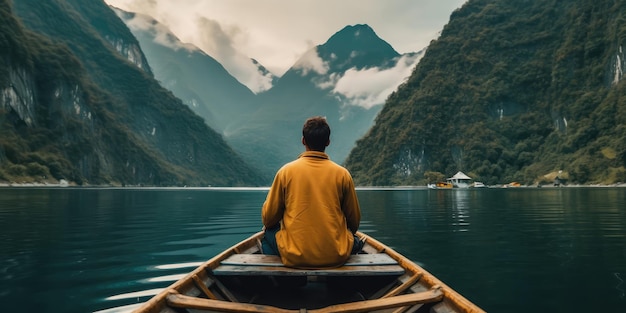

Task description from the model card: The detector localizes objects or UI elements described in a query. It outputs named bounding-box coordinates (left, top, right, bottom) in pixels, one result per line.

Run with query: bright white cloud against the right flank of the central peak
left=330, top=53, right=423, bottom=109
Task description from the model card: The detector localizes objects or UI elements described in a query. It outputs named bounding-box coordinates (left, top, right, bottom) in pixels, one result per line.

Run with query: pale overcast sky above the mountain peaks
left=105, top=0, right=465, bottom=92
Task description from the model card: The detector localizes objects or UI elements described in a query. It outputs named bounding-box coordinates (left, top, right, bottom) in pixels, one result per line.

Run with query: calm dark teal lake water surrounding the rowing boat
left=0, top=188, right=626, bottom=313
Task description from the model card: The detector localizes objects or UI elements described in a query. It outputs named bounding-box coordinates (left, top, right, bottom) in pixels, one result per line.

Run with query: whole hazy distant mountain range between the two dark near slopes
left=107, top=14, right=422, bottom=184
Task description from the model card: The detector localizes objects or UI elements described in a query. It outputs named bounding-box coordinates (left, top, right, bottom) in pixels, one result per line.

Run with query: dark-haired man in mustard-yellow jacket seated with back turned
left=262, top=116, right=363, bottom=268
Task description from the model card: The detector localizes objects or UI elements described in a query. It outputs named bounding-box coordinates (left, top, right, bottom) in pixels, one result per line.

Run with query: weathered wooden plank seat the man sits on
left=212, top=253, right=404, bottom=276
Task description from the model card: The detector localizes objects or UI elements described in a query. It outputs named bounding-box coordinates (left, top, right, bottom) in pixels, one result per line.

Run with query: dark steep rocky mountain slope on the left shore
left=0, top=0, right=261, bottom=186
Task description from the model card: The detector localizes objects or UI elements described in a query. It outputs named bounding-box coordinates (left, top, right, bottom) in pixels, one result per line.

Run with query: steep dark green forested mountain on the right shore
left=346, top=0, right=626, bottom=185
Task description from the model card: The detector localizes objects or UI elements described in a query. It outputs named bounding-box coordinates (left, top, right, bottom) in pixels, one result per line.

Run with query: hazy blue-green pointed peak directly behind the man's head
left=224, top=25, right=420, bottom=177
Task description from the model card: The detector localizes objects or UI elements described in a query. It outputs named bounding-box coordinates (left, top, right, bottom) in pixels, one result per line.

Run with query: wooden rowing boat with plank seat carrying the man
left=134, top=232, right=484, bottom=313
